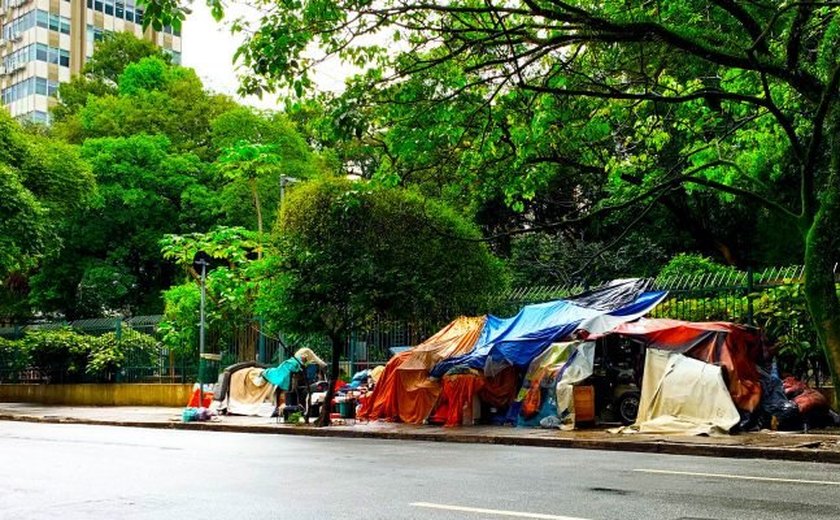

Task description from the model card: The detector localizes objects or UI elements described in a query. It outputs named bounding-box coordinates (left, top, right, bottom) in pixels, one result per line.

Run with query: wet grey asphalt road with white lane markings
left=0, top=421, right=840, bottom=520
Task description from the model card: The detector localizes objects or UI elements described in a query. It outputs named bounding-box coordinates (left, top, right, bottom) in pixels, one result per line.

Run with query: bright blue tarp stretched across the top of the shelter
left=430, top=291, right=666, bottom=377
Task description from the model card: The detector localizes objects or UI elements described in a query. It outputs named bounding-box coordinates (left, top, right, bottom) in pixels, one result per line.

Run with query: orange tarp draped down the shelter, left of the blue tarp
left=359, top=316, right=484, bottom=424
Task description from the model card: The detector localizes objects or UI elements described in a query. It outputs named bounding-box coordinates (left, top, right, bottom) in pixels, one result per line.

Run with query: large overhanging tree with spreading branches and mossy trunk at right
left=144, top=0, right=840, bottom=402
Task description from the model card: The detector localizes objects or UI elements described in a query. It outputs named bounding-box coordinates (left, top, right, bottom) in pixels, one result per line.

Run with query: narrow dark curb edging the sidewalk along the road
left=0, top=414, right=840, bottom=464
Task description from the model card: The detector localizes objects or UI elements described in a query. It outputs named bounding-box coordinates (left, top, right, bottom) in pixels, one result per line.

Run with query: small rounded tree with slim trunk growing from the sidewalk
left=258, top=179, right=502, bottom=424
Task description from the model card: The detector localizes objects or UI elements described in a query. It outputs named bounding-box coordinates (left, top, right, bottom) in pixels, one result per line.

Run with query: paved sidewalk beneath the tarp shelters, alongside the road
left=0, top=403, right=840, bottom=464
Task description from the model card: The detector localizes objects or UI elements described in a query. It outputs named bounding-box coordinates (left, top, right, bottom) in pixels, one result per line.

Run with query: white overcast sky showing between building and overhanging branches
left=182, top=0, right=349, bottom=109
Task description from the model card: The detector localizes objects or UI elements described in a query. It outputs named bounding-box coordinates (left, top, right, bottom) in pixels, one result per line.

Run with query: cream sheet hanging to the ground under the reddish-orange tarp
left=615, top=350, right=740, bottom=435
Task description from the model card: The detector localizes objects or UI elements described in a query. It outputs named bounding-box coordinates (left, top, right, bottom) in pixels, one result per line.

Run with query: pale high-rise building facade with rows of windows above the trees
left=0, top=0, right=181, bottom=123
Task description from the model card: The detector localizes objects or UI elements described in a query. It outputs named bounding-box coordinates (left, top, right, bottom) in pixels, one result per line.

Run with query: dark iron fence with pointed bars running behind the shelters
left=0, top=266, right=837, bottom=382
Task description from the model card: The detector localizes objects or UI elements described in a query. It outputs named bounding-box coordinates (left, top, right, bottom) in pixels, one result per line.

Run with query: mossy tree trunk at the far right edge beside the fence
left=805, top=138, right=840, bottom=405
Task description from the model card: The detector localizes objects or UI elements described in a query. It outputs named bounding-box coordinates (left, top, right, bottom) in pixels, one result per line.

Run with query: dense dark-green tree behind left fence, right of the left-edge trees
left=32, top=135, right=219, bottom=317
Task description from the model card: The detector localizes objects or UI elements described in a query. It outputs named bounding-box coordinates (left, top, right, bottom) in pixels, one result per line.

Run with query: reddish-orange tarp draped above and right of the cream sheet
left=612, top=319, right=764, bottom=412
